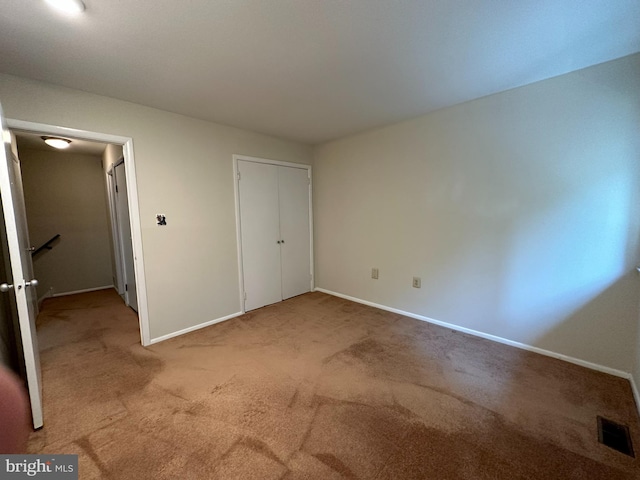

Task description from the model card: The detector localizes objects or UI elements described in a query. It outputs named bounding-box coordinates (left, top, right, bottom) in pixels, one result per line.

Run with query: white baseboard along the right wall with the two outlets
left=315, top=288, right=640, bottom=380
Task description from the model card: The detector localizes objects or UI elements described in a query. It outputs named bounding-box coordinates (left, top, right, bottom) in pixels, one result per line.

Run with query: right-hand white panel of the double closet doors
left=278, top=167, right=311, bottom=299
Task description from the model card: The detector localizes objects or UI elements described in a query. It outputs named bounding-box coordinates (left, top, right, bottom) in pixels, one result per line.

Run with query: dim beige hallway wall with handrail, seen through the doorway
left=19, top=149, right=113, bottom=298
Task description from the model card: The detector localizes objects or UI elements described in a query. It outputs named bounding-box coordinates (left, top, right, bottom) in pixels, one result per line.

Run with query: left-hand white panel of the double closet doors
left=238, top=160, right=282, bottom=311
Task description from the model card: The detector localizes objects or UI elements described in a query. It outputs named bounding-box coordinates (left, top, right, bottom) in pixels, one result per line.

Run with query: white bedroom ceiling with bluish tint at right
left=0, top=0, right=640, bottom=143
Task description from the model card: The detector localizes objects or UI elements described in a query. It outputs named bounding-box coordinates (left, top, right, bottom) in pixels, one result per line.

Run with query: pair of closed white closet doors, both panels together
left=238, top=160, right=311, bottom=311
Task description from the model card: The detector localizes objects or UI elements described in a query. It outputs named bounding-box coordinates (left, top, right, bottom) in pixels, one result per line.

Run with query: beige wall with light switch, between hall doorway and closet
left=0, top=75, right=312, bottom=339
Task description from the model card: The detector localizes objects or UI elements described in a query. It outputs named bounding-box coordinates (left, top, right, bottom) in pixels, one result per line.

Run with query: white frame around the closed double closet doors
left=233, top=155, right=315, bottom=313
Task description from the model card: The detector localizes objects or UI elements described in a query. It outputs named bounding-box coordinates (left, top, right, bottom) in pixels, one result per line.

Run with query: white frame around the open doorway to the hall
left=7, top=118, right=151, bottom=347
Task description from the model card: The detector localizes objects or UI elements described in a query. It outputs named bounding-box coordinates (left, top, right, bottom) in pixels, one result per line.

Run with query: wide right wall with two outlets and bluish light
left=314, top=55, right=640, bottom=376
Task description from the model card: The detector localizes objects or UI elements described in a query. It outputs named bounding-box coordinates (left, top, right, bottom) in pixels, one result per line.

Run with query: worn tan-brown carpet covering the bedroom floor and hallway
left=29, top=291, right=640, bottom=480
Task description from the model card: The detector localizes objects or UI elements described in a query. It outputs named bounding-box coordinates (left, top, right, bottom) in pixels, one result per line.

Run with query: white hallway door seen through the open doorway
left=113, top=162, right=138, bottom=312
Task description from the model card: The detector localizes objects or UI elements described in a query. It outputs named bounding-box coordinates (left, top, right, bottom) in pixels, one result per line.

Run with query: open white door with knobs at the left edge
left=0, top=103, right=43, bottom=428
